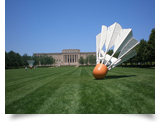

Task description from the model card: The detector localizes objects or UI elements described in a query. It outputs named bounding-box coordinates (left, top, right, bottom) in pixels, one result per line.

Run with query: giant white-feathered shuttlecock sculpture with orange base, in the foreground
left=93, top=22, right=139, bottom=79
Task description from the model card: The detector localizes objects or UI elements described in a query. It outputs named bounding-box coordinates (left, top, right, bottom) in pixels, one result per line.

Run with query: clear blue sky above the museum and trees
left=5, top=0, right=155, bottom=56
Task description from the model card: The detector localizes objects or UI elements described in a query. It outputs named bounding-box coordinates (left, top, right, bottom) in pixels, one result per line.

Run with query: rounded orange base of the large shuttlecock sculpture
left=93, top=63, right=108, bottom=79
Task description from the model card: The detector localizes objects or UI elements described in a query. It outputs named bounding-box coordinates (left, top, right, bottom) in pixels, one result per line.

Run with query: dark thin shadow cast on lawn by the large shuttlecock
left=94, top=75, right=136, bottom=80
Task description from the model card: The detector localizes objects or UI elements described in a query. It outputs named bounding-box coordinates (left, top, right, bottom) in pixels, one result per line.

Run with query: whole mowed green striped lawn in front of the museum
left=5, top=67, right=155, bottom=114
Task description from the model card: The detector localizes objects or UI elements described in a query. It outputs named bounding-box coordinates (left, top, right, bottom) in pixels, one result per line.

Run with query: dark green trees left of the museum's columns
left=5, top=51, right=55, bottom=69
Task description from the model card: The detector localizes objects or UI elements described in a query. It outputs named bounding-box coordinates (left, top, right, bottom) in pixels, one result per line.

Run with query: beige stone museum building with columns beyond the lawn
left=33, top=49, right=96, bottom=66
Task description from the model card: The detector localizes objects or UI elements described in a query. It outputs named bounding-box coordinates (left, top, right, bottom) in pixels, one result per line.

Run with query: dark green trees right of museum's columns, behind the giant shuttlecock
left=79, top=28, right=155, bottom=66
